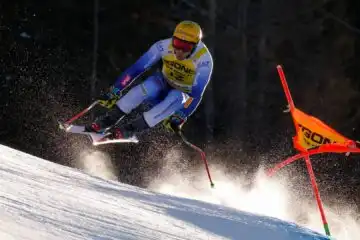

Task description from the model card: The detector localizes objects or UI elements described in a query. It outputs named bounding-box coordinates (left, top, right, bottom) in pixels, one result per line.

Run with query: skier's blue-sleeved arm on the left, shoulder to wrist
left=114, top=40, right=164, bottom=93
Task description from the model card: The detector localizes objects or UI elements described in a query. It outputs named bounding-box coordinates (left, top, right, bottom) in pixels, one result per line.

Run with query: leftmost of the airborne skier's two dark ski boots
left=85, top=106, right=126, bottom=133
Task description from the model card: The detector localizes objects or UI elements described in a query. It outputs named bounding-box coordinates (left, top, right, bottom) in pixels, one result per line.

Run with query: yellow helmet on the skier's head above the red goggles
left=173, top=21, right=202, bottom=44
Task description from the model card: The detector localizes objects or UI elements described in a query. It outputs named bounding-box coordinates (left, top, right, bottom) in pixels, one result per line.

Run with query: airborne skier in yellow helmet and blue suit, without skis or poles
left=85, top=21, right=213, bottom=139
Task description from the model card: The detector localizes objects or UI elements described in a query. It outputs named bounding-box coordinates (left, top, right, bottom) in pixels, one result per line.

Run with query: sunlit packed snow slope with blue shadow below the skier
left=0, top=145, right=328, bottom=240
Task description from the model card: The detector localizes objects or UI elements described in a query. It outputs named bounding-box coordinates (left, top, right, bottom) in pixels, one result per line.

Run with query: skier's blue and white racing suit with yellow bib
left=114, top=38, right=213, bottom=127
